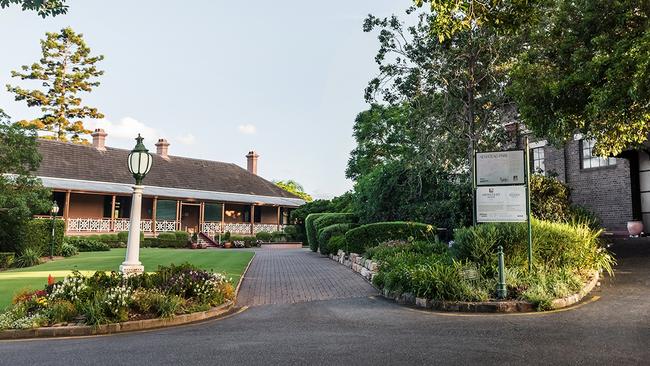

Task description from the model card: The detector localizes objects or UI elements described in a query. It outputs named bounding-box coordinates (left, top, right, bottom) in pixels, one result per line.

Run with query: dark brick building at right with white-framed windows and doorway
left=529, top=135, right=650, bottom=234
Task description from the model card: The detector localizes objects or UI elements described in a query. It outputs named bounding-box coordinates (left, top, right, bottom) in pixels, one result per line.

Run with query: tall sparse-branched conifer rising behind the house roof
left=7, top=28, right=104, bottom=142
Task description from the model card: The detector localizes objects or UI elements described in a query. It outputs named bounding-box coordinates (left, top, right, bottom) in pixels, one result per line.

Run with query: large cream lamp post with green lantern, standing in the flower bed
left=120, top=134, right=153, bottom=275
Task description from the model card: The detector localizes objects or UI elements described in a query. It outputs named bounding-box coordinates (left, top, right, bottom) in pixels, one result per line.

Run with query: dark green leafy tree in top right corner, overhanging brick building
left=511, top=0, right=650, bottom=155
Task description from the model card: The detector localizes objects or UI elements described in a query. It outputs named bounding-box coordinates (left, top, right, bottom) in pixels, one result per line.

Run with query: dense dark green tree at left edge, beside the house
left=0, top=112, right=51, bottom=251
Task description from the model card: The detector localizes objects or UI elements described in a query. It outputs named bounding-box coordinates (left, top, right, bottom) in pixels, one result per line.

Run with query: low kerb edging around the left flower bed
left=0, top=252, right=255, bottom=340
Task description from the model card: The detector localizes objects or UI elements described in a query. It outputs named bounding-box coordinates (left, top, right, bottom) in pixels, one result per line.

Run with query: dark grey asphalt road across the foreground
left=0, top=243, right=650, bottom=366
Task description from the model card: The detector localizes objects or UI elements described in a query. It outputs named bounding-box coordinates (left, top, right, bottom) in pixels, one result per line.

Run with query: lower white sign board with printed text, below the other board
left=476, top=185, right=528, bottom=222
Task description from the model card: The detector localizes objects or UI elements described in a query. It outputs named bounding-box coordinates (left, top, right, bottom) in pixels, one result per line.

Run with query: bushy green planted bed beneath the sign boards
left=332, top=220, right=615, bottom=311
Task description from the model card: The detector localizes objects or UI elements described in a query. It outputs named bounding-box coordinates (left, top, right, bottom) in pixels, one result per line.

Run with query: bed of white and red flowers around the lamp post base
left=0, top=264, right=235, bottom=330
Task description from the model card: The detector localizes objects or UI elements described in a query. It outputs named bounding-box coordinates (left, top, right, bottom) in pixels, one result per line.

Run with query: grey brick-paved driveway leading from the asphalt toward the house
left=237, top=249, right=377, bottom=306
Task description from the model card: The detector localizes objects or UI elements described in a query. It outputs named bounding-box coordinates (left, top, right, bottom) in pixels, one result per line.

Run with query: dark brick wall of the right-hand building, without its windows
left=544, top=141, right=632, bottom=230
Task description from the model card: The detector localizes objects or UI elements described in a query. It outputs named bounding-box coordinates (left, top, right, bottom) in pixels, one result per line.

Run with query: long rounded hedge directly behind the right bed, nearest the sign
left=345, top=221, right=437, bottom=254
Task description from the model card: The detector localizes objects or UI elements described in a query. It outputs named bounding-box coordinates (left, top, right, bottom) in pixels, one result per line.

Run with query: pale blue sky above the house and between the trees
left=0, top=0, right=411, bottom=198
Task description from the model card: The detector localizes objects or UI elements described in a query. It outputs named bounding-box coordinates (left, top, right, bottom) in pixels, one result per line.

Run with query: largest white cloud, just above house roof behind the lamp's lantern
left=86, top=117, right=160, bottom=147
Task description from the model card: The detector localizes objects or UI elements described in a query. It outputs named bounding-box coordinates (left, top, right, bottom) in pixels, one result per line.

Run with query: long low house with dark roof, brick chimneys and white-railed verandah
left=36, top=129, right=304, bottom=236
